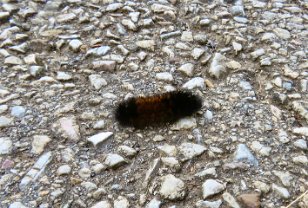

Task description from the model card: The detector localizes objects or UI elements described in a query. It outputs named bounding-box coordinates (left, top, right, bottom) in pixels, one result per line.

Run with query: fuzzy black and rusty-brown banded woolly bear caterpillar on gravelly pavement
left=115, top=91, right=202, bottom=128
